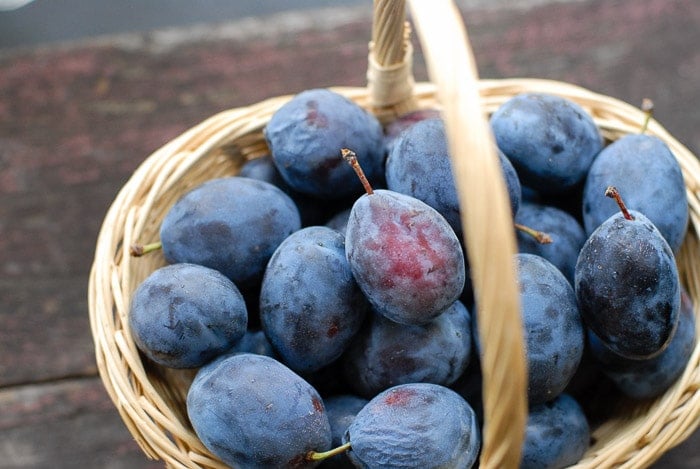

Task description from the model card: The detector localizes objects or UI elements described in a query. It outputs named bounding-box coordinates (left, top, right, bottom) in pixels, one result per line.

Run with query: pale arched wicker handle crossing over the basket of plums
left=368, top=0, right=527, bottom=468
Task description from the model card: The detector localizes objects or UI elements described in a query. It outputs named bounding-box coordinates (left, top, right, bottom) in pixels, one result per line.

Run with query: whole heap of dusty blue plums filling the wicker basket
left=129, top=89, right=695, bottom=468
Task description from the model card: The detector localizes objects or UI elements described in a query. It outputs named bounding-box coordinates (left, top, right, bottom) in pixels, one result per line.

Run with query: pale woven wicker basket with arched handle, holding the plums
left=89, top=0, right=700, bottom=468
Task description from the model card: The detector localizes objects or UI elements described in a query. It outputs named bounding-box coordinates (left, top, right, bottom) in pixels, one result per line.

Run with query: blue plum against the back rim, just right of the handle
left=491, top=93, right=603, bottom=194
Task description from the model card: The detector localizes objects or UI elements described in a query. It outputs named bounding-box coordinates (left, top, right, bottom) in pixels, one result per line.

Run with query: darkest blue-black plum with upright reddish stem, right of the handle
left=574, top=202, right=681, bottom=359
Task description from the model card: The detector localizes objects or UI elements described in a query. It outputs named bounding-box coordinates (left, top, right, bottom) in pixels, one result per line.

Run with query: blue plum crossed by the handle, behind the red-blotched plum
left=386, top=118, right=521, bottom=234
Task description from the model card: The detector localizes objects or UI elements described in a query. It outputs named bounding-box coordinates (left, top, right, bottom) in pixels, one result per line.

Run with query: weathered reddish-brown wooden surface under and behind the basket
left=0, top=0, right=700, bottom=468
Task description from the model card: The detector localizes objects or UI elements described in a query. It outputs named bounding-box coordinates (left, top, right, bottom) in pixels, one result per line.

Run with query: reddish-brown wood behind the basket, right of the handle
left=464, top=0, right=700, bottom=154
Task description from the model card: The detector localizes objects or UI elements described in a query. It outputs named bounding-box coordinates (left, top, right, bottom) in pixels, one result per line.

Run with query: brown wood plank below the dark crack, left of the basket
left=0, top=378, right=163, bottom=469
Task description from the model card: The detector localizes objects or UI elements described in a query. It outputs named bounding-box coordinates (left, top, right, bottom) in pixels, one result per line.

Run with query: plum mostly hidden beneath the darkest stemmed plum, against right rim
left=588, top=292, right=696, bottom=399
